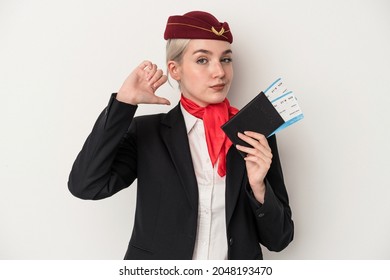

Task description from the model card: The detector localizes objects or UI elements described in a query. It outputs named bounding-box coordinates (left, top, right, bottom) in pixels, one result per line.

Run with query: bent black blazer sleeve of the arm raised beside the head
left=68, top=93, right=137, bottom=200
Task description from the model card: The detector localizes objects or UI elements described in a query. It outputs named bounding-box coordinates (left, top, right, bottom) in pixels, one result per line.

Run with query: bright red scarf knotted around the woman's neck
left=180, top=95, right=238, bottom=177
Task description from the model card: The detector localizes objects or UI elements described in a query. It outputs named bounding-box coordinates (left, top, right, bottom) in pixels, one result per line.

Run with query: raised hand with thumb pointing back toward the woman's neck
left=116, top=61, right=170, bottom=105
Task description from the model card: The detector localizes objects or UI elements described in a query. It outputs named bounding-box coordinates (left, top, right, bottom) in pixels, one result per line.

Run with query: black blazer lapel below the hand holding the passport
left=226, top=146, right=246, bottom=226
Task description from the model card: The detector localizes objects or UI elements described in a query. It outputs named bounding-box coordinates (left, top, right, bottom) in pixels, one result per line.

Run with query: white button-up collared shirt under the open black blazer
left=181, top=106, right=228, bottom=260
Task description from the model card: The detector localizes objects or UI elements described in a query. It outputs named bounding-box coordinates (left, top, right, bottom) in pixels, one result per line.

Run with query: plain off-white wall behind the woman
left=0, top=0, right=390, bottom=260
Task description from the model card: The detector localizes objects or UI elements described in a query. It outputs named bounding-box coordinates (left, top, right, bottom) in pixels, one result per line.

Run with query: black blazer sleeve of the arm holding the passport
left=247, top=136, right=294, bottom=252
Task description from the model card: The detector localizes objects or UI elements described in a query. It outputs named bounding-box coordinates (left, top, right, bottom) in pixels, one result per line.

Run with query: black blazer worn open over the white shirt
left=68, top=94, right=294, bottom=259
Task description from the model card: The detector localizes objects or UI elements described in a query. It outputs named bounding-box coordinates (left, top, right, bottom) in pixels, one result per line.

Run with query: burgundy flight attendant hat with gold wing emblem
left=164, top=11, right=233, bottom=43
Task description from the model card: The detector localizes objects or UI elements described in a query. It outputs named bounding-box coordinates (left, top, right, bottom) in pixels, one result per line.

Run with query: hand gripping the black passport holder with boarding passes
left=236, top=131, right=272, bottom=203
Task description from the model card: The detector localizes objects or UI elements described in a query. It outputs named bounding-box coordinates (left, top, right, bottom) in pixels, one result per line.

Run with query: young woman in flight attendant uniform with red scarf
left=68, top=11, right=294, bottom=259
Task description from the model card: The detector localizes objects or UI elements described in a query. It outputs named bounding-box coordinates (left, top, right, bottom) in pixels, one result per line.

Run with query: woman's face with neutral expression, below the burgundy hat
left=170, top=40, right=233, bottom=107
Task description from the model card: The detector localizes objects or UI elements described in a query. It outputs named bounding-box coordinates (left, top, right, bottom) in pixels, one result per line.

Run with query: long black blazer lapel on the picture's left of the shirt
left=161, top=105, right=198, bottom=209
